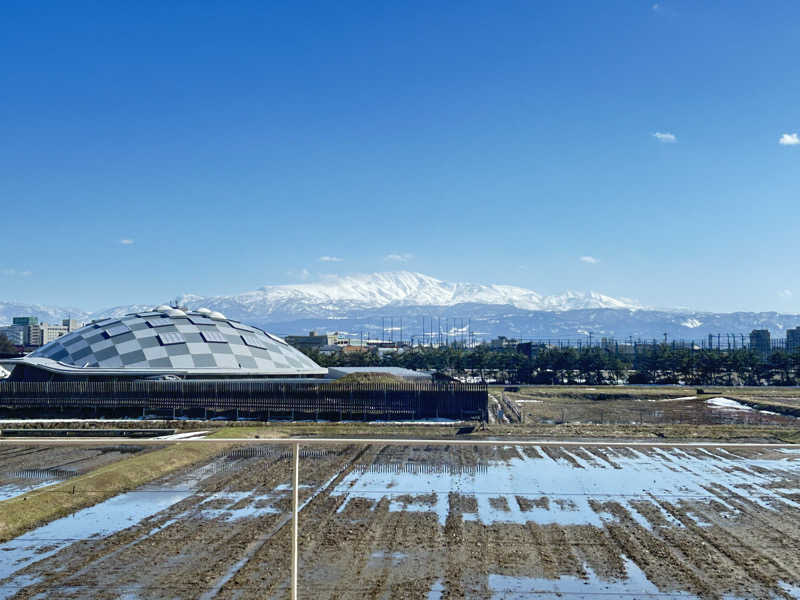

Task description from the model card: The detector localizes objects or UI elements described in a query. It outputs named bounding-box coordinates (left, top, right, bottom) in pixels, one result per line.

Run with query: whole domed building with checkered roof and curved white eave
left=0, top=306, right=327, bottom=381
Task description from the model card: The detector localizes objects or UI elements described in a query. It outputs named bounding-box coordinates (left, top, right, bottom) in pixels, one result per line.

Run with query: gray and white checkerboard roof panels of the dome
left=30, top=312, right=320, bottom=375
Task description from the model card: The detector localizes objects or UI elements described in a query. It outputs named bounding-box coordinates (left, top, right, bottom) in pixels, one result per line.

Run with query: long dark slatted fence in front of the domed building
left=0, top=381, right=488, bottom=420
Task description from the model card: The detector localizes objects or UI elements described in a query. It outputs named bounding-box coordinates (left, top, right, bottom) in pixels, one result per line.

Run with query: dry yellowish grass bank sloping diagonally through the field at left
left=0, top=444, right=224, bottom=542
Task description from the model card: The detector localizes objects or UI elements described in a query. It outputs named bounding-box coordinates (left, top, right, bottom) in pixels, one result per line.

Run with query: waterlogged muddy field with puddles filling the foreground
left=0, top=445, right=800, bottom=600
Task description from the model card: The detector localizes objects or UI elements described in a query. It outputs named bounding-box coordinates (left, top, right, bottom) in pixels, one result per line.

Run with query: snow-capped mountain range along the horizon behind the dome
left=0, top=271, right=800, bottom=339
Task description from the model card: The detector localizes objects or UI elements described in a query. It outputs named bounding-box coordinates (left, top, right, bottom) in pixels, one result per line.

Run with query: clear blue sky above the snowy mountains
left=0, top=0, right=800, bottom=312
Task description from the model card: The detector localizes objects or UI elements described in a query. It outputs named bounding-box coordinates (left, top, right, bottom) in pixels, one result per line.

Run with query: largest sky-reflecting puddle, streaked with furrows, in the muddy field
left=332, top=447, right=800, bottom=529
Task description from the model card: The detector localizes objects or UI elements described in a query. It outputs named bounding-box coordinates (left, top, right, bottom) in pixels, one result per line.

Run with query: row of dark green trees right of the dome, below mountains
left=305, top=344, right=800, bottom=385
